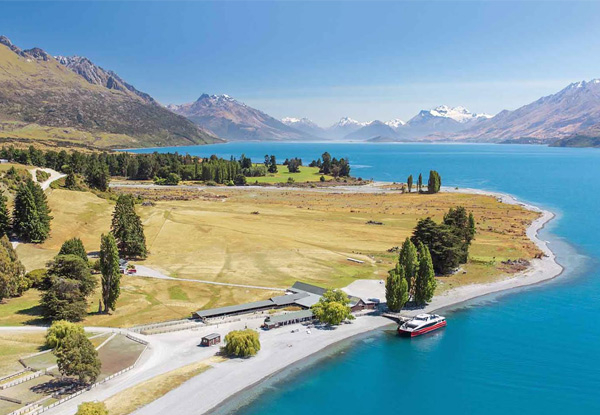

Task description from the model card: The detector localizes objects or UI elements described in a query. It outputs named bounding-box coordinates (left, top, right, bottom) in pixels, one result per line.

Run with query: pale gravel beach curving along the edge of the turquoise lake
left=134, top=185, right=564, bottom=415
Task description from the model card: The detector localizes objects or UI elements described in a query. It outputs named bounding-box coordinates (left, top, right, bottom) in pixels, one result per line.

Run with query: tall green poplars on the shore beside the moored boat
left=385, top=238, right=437, bottom=311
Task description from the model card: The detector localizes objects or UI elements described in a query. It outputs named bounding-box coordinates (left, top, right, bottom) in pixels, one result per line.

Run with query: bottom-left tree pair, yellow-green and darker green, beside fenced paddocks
left=46, top=321, right=102, bottom=384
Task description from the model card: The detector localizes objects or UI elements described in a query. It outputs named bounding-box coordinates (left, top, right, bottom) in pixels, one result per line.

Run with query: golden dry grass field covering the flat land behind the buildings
left=0, top=188, right=537, bottom=326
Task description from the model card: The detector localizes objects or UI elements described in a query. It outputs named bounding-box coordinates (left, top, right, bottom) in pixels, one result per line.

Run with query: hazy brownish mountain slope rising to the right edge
left=452, top=79, right=600, bottom=142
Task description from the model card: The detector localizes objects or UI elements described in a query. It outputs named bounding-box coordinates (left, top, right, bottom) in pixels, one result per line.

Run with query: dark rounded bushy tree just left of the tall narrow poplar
left=40, top=277, right=87, bottom=321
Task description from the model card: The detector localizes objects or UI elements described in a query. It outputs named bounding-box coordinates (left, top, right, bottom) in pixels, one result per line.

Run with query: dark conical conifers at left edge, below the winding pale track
left=0, top=178, right=52, bottom=243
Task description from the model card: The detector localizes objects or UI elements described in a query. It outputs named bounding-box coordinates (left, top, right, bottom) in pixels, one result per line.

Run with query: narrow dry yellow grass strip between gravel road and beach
left=104, top=357, right=223, bottom=415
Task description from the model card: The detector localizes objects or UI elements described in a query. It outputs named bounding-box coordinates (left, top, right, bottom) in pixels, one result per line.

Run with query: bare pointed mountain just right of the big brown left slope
left=167, top=94, right=314, bottom=140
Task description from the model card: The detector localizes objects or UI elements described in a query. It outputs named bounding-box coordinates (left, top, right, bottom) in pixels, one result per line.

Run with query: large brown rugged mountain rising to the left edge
left=0, top=36, right=222, bottom=148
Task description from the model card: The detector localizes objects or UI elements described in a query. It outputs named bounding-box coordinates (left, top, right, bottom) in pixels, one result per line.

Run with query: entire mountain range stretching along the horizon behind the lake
left=0, top=36, right=600, bottom=148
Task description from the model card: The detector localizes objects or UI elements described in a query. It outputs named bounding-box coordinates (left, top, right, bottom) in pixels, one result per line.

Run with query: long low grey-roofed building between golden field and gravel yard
left=192, top=281, right=374, bottom=320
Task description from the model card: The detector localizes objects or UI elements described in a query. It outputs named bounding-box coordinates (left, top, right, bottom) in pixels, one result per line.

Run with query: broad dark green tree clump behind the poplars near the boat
left=411, top=206, right=476, bottom=274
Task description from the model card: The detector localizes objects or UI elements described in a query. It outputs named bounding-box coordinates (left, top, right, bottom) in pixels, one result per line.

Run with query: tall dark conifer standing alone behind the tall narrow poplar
left=111, top=195, right=147, bottom=258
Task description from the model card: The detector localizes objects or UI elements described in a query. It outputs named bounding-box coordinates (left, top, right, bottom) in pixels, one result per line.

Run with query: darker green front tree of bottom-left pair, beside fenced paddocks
left=54, top=332, right=102, bottom=383
